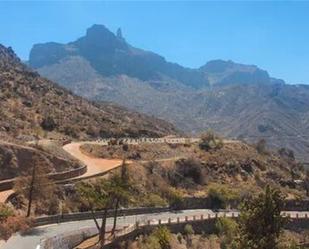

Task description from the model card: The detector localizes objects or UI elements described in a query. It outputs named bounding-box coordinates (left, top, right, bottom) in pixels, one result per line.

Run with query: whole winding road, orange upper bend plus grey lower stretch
left=0, top=138, right=309, bottom=249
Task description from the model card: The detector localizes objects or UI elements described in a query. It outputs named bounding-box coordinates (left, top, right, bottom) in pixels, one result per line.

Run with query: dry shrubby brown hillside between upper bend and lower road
left=60, top=141, right=306, bottom=213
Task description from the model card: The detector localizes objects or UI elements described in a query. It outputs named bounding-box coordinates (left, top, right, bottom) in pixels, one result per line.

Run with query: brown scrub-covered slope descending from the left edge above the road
left=0, top=45, right=176, bottom=140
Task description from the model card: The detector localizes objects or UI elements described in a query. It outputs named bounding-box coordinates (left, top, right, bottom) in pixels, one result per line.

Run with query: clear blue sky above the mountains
left=0, top=1, right=309, bottom=84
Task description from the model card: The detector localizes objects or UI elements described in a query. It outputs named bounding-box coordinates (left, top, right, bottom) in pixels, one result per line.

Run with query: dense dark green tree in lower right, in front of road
left=238, top=186, right=286, bottom=249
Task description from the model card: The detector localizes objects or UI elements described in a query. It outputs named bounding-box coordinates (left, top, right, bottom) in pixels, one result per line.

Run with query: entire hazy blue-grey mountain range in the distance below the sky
left=29, top=25, right=309, bottom=160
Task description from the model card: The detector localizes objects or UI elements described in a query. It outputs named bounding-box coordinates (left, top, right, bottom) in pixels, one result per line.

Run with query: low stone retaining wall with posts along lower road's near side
left=41, top=213, right=309, bottom=249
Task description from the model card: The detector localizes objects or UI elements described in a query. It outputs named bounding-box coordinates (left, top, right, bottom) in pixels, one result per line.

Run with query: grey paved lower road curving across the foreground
left=0, top=209, right=214, bottom=249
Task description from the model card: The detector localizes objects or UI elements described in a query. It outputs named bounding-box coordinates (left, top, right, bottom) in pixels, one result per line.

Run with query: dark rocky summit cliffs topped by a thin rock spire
left=29, top=25, right=207, bottom=88
